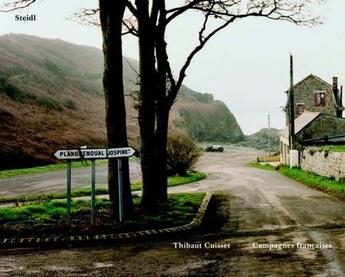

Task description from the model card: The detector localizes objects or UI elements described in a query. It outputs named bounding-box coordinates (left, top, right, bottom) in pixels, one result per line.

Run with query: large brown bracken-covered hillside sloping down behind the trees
left=0, top=34, right=243, bottom=169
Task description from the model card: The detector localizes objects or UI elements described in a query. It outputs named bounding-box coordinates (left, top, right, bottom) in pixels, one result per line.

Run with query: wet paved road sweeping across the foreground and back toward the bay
left=0, top=148, right=345, bottom=276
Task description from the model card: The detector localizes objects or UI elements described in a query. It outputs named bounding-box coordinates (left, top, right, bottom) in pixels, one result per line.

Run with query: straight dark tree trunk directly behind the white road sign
left=99, top=0, right=133, bottom=220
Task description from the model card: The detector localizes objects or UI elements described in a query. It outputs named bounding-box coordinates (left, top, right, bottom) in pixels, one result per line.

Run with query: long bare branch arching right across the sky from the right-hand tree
left=166, top=0, right=324, bottom=105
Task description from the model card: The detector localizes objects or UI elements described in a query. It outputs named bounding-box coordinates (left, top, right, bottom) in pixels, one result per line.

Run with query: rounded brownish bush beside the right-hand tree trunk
left=167, top=133, right=202, bottom=176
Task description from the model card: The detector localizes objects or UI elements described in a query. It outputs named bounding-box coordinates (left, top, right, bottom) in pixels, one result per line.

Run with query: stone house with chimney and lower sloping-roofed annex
left=280, top=74, right=345, bottom=164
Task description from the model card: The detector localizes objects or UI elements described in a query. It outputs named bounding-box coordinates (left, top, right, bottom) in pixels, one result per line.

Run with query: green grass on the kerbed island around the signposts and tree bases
left=0, top=193, right=205, bottom=225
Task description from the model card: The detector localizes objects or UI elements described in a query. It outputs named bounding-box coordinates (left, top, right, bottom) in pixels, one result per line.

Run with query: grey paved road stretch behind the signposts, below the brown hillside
left=0, top=159, right=141, bottom=197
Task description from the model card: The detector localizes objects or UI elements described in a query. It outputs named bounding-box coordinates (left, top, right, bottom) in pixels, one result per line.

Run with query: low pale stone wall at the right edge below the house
left=301, top=148, right=345, bottom=181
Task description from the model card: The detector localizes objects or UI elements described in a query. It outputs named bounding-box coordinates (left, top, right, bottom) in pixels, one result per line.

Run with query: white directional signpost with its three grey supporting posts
left=54, top=147, right=135, bottom=225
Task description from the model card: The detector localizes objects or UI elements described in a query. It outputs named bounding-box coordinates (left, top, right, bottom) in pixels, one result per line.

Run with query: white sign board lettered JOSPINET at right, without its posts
left=54, top=147, right=135, bottom=160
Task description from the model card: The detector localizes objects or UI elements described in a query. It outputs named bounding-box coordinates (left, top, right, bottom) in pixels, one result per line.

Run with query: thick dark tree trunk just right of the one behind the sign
left=136, top=0, right=168, bottom=211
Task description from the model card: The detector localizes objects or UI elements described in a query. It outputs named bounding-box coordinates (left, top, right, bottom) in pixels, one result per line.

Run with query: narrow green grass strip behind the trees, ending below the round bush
left=0, top=171, right=206, bottom=204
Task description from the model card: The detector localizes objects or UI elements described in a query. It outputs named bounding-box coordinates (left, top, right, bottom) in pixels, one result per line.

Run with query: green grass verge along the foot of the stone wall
left=250, top=163, right=345, bottom=195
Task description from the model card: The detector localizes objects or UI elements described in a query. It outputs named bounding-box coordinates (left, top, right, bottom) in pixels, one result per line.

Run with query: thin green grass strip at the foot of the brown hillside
left=0, top=160, right=107, bottom=179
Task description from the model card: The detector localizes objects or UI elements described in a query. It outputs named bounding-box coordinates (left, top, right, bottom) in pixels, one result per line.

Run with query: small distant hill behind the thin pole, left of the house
left=240, top=128, right=281, bottom=152
